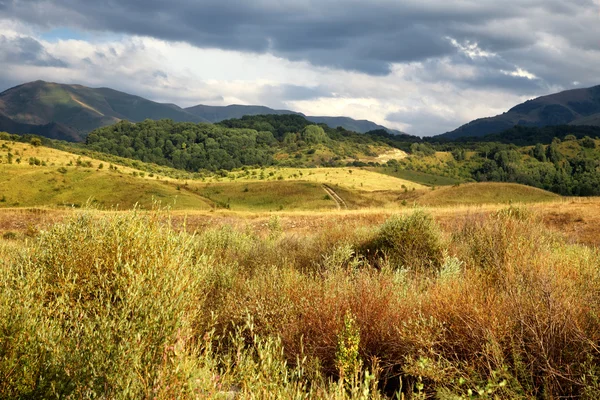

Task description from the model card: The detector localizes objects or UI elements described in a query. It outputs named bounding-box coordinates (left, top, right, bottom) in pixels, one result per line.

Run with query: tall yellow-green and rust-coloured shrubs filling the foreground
left=0, top=207, right=600, bottom=399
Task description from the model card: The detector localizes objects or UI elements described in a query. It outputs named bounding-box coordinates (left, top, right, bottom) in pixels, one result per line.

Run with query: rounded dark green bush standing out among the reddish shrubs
left=366, top=211, right=444, bottom=272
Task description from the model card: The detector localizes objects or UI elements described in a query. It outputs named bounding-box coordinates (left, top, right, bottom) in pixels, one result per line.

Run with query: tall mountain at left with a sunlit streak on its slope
left=0, top=81, right=206, bottom=141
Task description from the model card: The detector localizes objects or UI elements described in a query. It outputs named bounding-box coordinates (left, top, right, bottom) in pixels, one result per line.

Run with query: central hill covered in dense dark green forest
left=86, top=115, right=412, bottom=172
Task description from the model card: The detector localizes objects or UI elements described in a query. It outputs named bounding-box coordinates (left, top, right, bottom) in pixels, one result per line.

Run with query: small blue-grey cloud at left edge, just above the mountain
left=0, top=35, right=68, bottom=68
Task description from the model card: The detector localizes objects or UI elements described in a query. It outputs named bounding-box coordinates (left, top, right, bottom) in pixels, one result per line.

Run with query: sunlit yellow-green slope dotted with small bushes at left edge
left=0, top=142, right=210, bottom=210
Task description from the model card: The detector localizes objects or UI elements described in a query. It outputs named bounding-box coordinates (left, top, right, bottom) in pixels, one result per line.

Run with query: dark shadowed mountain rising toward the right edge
left=436, top=86, right=600, bottom=139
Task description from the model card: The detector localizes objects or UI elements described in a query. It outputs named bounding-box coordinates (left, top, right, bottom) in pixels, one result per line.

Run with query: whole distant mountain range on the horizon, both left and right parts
left=0, top=81, right=600, bottom=142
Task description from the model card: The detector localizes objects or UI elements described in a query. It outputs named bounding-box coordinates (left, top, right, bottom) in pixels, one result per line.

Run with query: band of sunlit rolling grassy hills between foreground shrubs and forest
left=0, top=142, right=572, bottom=212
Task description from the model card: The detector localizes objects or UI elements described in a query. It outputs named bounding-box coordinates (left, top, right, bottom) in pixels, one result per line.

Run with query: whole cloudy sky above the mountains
left=0, top=0, right=600, bottom=136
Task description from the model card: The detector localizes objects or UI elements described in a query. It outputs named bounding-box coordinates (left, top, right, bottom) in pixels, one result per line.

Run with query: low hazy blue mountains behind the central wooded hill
left=185, top=104, right=403, bottom=135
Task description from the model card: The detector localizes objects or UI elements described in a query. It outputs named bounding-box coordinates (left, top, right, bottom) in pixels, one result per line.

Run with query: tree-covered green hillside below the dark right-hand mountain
left=386, top=134, right=600, bottom=196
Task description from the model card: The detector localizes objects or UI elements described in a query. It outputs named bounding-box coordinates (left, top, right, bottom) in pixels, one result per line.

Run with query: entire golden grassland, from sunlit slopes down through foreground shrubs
left=0, top=138, right=600, bottom=399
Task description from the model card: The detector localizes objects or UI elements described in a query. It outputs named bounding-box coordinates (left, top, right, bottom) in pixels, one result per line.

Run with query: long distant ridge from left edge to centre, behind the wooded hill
left=0, top=81, right=400, bottom=141
